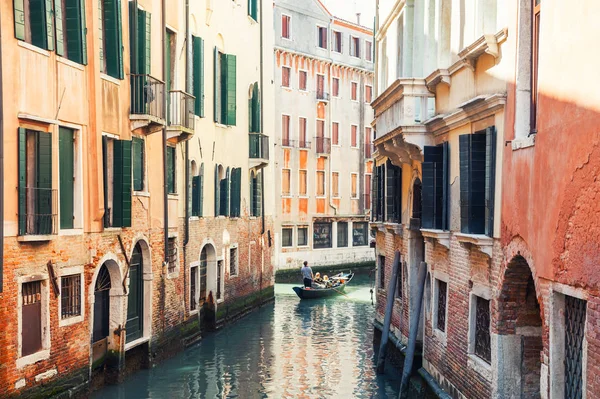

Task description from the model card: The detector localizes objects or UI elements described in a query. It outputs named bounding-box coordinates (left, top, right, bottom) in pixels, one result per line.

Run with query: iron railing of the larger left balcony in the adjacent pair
left=130, top=74, right=165, bottom=120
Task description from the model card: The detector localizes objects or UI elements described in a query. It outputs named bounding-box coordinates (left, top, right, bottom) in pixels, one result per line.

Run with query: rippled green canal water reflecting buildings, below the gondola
left=93, top=275, right=400, bottom=399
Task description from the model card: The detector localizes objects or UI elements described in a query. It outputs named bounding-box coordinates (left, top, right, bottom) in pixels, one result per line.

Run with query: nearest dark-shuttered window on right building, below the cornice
left=460, top=127, right=496, bottom=237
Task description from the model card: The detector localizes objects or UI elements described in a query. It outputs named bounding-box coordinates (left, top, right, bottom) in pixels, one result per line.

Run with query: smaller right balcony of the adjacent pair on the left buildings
left=167, top=90, right=196, bottom=141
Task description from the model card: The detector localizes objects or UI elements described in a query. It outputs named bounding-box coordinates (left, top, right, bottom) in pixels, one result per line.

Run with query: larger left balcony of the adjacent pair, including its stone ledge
left=129, top=74, right=166, bottom=133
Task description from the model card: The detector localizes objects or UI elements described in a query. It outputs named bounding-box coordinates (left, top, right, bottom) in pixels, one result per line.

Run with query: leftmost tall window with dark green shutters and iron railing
left=18, top=128, right=55, bottom=235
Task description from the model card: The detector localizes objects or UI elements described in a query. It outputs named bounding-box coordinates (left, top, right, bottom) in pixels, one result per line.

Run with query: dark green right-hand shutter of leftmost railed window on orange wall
left=35, top=132, right=55, bottom=235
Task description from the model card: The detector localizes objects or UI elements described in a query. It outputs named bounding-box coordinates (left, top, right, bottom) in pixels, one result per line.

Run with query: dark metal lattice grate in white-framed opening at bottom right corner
left=565, top=296, right=587, bottom=399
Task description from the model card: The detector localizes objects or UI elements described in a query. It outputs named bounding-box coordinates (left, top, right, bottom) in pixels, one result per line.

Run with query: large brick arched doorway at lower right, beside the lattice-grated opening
left=497, top=255, right=543, bottom=399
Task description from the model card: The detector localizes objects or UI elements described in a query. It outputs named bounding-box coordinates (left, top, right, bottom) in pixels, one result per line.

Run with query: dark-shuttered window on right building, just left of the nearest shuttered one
left=421, top=142, right=450, bottom=230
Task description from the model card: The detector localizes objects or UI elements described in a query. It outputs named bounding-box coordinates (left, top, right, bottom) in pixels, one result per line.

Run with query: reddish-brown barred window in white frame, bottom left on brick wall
left=21, top=281, right=45, bottom=356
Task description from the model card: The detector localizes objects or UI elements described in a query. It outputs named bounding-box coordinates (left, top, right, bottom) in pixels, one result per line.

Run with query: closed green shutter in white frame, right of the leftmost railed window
left=58, top=127, right=75, bottom=229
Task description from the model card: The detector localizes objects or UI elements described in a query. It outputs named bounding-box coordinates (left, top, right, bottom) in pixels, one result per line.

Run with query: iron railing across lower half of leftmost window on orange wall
left=19, top=187, right=58, bottom=236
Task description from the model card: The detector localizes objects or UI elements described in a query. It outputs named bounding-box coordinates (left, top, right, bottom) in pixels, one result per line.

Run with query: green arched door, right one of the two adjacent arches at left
left=125, top=243, right=144, bottom=342
